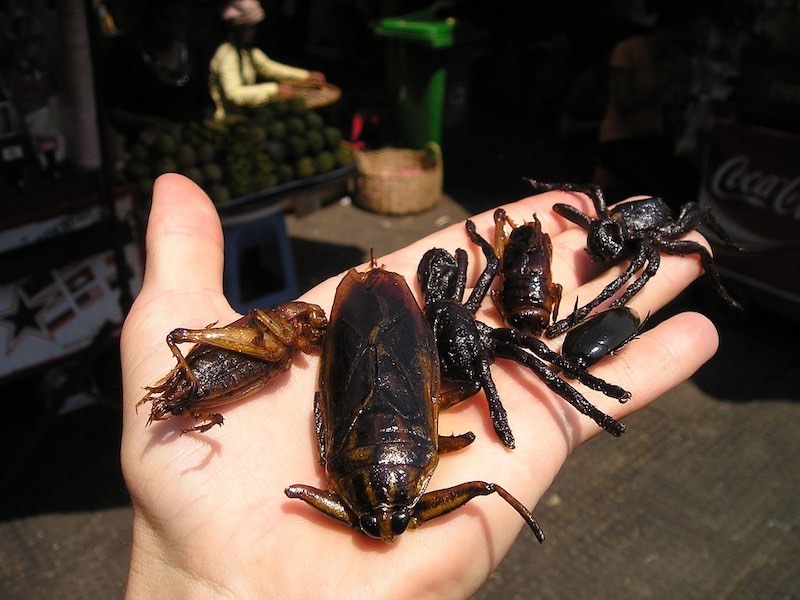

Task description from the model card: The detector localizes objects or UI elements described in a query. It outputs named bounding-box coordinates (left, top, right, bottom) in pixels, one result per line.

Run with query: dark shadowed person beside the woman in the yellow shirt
left=103, top=0, right=213, bottom=137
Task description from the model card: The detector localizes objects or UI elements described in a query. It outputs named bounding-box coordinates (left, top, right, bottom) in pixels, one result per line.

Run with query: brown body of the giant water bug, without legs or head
left=316, top=268, right=439, bottom=517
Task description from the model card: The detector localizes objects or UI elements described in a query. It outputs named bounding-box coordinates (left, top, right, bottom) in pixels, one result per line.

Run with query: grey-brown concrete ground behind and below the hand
left=0, top=184, right=800, bottom=600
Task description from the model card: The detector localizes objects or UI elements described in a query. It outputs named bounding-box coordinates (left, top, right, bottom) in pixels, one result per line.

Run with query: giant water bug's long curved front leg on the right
left=411, top=481, right=544, bottom=543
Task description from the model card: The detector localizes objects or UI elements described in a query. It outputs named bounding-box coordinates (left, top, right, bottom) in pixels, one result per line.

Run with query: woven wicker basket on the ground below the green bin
left=355, top=142, right=444, bottom=215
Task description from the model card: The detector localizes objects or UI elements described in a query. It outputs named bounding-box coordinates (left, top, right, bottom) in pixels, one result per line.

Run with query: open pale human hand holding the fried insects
left=121, top=175, right=717, bottom=598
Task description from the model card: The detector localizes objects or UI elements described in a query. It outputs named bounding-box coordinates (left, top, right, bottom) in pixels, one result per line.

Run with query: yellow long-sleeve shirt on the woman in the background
left=209, top=42, right=309, bottom=119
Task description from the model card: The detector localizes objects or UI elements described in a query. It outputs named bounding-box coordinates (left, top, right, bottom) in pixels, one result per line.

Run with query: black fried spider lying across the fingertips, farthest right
left=528, top=179, right=742, bottom=338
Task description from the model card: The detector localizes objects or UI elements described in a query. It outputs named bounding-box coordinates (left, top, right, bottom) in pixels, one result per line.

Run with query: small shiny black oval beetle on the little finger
left=561, top=306, right=642, bottom=369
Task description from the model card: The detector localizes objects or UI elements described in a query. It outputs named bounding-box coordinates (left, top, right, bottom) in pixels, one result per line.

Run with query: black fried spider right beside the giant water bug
left=417, top=221, right=630, bottom=448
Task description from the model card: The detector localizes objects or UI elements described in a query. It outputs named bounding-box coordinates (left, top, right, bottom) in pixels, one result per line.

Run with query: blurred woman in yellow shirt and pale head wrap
left=209, top=0, right=325, bottom=119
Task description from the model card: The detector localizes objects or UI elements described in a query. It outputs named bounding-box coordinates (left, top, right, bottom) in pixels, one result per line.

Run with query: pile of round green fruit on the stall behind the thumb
left=125, top=98, right=353, bottom=203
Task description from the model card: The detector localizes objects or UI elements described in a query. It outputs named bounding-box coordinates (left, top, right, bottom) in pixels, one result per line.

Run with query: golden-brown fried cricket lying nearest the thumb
left=136, top=302, right=327, bottom=433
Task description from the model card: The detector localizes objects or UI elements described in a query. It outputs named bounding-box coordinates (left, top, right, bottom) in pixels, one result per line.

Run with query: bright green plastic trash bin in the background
left=375, top=2, right=477, bottom=180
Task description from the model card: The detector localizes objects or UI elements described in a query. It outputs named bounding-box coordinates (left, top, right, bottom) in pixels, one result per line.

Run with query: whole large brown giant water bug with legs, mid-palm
left=286, top=264, right=544, bottom=543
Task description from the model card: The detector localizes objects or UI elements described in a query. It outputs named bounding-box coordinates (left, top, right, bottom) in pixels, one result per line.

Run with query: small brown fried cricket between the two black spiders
left=492, top=208, right=561, bottom=335
